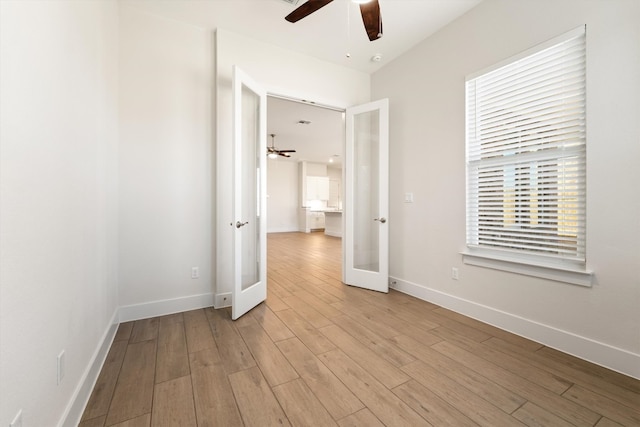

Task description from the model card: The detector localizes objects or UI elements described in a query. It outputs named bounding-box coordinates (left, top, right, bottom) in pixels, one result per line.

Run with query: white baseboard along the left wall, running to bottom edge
left=58, top=308, right=118, bottom=427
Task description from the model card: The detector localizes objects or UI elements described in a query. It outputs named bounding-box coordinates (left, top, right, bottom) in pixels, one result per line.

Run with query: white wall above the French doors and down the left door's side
left=216, top=29, right=370, bottom=295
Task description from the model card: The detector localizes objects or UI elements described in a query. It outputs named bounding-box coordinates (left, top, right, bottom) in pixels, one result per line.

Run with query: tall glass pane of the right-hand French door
left=353, top=111, right=380, bottom=272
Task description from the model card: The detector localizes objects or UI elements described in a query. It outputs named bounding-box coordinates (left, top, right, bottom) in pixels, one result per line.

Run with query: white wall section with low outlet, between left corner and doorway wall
left=119, top=3, right=215, bottom=319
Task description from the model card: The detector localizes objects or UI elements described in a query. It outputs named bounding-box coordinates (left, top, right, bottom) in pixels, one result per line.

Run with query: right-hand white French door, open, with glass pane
left=343, top=99, right=389, bottom=292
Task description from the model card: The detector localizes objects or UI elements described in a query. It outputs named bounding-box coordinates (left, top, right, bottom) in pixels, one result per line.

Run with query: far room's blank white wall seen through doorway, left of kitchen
left=267, top=159, right=300, bottom=233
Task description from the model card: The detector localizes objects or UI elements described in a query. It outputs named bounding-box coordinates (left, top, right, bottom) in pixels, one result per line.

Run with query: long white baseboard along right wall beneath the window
left=389, top=277, right=640, bottom=379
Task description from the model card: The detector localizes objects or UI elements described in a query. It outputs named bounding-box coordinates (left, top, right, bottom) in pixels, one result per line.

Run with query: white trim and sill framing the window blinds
left=460, top=25, right=594, bottom=287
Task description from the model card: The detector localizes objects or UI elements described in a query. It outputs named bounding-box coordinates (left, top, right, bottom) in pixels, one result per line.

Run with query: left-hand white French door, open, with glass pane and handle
left=230, top=67, right=267, bottom=320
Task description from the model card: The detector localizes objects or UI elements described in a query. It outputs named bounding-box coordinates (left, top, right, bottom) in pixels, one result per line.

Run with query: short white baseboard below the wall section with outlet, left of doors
left=119, top=293, right=214, bottom=322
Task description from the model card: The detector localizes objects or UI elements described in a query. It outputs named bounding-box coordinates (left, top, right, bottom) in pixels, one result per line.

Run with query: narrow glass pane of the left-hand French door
left=240, top=86, right=261, bottom=290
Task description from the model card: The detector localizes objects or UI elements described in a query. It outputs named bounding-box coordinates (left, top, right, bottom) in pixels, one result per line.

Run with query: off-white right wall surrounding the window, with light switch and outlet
left=372, top=0, right=640, bottom=376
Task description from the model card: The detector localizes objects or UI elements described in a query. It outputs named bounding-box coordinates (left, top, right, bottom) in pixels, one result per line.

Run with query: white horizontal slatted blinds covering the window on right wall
left=466, top=28, right=586, bottom=262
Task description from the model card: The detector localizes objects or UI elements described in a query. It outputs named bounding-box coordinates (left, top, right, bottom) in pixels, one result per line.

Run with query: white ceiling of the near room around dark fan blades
left=120, top=0, right=480, bottom=73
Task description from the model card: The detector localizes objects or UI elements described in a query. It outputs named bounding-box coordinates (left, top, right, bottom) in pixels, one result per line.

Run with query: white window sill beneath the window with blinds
left=461, top=251, right=593, bottom=287
